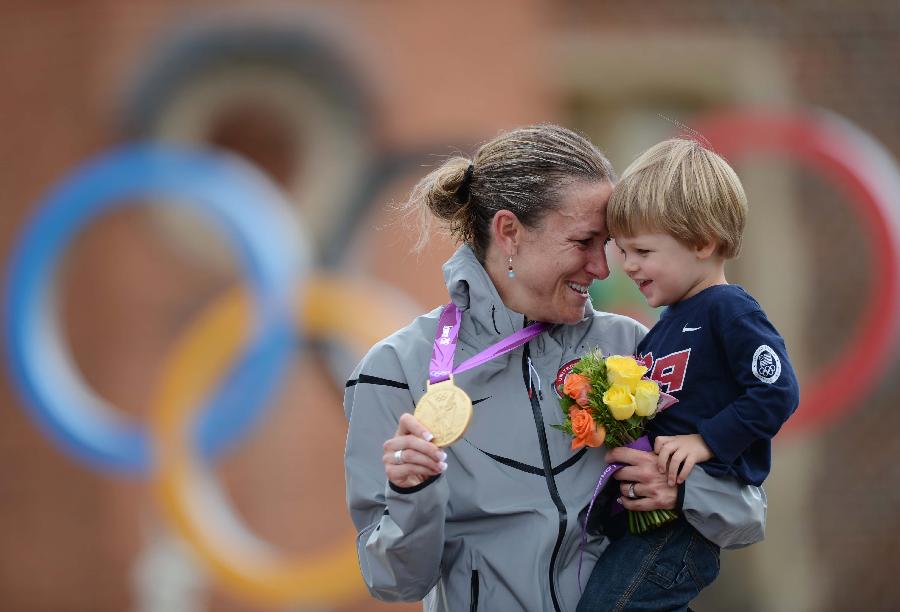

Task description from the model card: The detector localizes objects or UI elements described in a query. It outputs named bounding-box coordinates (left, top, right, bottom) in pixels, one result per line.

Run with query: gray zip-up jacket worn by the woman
left=344, top=246, right=766, bottom=611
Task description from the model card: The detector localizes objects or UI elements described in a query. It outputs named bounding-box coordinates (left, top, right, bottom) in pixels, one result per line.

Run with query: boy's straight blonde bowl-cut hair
left=606, top=138, right=747, bottom=259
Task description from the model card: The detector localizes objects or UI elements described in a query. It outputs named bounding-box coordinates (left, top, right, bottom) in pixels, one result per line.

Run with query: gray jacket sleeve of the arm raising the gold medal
left=344, top=345, right=449, bottom=601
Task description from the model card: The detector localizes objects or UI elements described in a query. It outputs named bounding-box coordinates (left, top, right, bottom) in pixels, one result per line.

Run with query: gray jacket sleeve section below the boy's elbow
left=681, top=469, right=768, bottom=548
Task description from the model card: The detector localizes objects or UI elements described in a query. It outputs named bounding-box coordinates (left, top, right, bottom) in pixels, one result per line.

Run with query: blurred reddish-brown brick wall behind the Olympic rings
left=0, top=0, right=900, bottom=612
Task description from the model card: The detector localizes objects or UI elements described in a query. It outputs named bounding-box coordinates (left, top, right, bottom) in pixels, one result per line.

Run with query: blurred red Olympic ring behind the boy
left=696, top=110, right=900, bottom=433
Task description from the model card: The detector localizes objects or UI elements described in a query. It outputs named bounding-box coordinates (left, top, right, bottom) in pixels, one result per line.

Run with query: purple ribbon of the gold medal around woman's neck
left=428, top=302, right=550, bottom=384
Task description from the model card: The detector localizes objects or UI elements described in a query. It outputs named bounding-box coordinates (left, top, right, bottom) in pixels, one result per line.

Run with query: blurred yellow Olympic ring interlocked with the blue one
left=151, top=277, right=420, bottom=605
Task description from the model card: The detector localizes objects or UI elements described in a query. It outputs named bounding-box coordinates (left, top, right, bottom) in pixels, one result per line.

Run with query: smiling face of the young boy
left=616, top=232, right=725, bottom=308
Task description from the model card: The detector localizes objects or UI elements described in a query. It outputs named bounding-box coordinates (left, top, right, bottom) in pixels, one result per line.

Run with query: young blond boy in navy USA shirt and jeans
left=578, top=139, right=799, bottom=610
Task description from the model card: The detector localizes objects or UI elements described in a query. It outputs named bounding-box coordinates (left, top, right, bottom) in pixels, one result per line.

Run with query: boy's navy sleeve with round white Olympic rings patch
left=698, top=311, right=800, bottom=465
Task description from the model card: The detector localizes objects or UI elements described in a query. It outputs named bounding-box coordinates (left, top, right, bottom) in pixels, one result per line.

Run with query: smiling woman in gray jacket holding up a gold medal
left=345, top=125, right=765, bottom=611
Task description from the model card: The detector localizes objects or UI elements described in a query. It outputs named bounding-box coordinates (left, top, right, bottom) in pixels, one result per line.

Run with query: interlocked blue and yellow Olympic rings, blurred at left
left=1, top=147, right=422, bottom=605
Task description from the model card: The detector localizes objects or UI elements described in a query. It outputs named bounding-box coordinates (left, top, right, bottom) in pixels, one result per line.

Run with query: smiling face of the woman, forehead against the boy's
left=507, top=181, right=612, bottom=323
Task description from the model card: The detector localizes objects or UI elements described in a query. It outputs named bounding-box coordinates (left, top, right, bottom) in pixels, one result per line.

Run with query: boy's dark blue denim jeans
left=578, top=517, right=719, bottom=612
